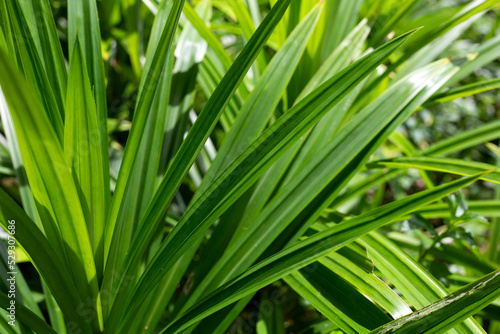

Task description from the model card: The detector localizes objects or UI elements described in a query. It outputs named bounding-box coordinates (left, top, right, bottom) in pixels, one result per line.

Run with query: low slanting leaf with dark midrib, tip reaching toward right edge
left=162, top=174, right=482, bottom=333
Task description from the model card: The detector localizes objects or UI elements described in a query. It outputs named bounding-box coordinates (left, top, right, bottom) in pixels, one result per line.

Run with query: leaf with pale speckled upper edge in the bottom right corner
left=371, top=270, right=500, bottom=334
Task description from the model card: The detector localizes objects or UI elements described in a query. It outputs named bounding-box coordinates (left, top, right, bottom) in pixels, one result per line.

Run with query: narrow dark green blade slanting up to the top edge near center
left=104, top=0, right=290, bottom=328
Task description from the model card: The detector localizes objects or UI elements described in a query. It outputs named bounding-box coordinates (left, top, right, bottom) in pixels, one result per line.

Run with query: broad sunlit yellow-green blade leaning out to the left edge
left=0, top=50, right=101, bottom=329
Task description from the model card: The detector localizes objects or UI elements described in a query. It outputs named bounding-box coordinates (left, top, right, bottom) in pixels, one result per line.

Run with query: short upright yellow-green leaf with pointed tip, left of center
left=64, top=36, right=109, bottom=280
